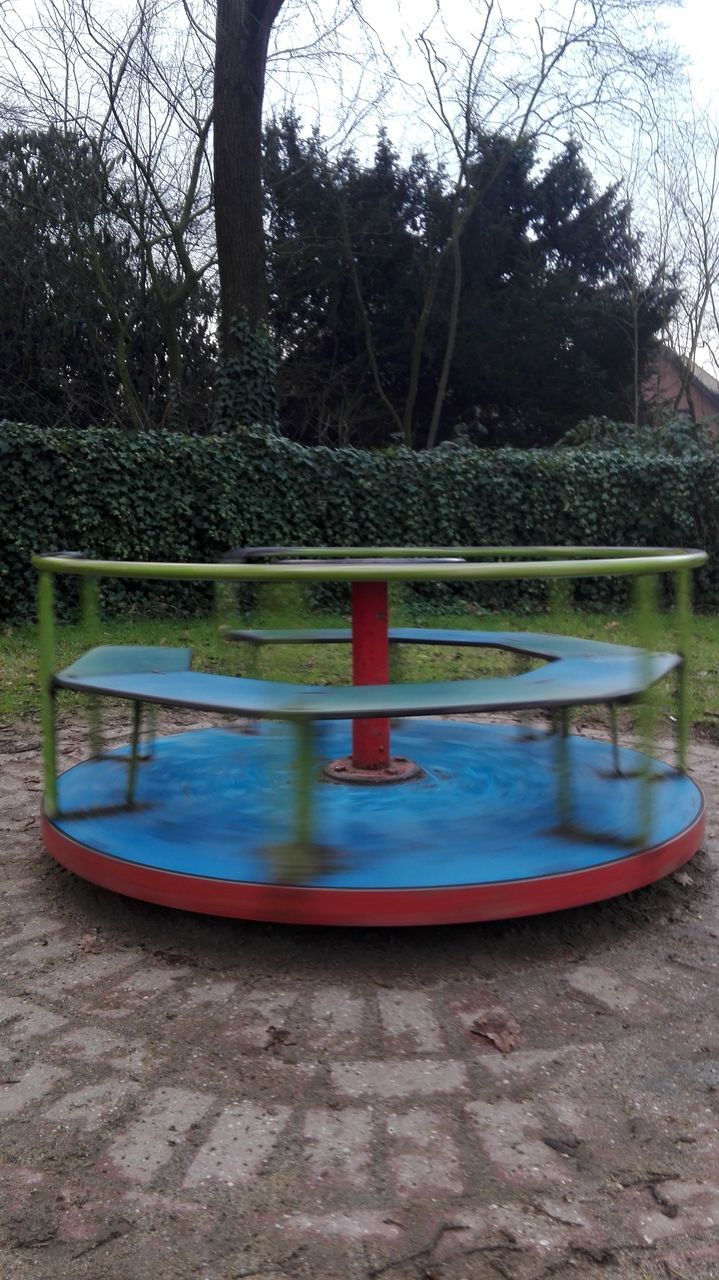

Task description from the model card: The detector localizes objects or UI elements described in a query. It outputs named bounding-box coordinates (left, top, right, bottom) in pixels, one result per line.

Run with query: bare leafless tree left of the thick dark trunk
left=0, top=0, right=215, bottom=428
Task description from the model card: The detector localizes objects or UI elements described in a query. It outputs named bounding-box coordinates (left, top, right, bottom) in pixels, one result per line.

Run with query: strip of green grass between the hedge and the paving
left=0, top=599, right=719, bottom=730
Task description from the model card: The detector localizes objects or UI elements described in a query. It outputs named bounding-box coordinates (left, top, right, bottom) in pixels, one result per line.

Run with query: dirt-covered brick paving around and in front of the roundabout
left=0, top=723, right=719, bottom=1280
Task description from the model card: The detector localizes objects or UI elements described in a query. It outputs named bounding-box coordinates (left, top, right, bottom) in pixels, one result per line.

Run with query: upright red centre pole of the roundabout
left=352, top=582, right=390, bottom=769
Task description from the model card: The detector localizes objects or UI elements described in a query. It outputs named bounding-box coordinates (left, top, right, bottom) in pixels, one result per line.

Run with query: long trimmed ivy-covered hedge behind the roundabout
left=0, top=422, right=719, bottom=621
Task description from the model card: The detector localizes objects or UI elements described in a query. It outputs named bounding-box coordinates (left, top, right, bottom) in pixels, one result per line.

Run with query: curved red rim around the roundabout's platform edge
left=41, top=800, right=705, bottom=928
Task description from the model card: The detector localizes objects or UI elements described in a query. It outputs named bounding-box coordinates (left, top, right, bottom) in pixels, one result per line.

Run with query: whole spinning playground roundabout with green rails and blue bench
left=35, top=548, right=705, bottom=925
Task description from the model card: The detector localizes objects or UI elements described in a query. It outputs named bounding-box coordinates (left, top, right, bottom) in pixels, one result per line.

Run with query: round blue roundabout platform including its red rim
left=43, top=719, right=704, bottom=924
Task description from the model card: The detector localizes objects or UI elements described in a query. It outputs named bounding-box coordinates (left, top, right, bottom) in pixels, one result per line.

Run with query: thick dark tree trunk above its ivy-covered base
left=214, top=0, right=283, bottom=357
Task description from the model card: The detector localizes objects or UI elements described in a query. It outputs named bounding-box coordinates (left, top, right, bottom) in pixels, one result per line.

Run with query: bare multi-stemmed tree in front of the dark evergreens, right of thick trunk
left=335, top=0, right=673, bottom=447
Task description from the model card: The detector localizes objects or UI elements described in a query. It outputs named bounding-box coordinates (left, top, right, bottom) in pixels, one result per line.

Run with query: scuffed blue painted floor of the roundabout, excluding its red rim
left=51, top=721, right=702, bottom=890
